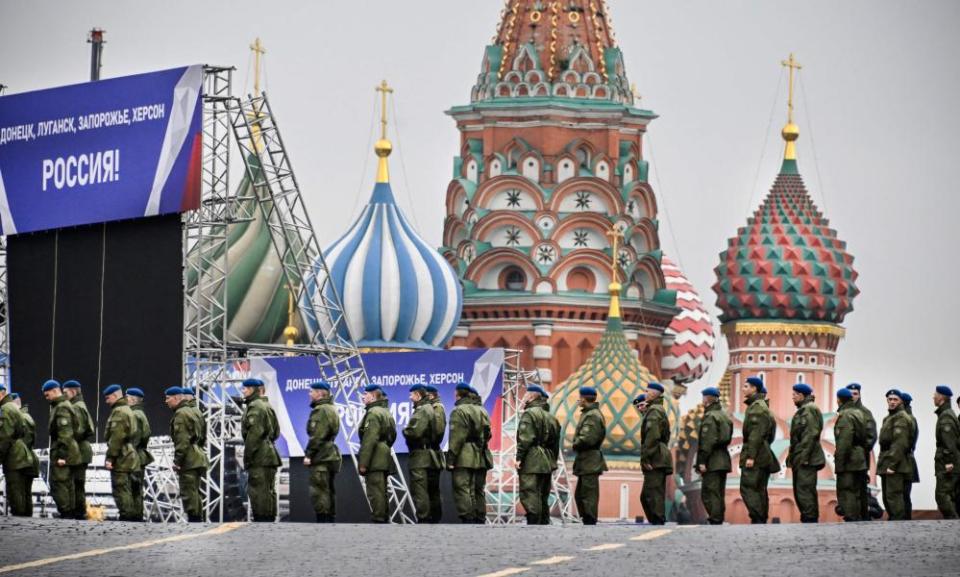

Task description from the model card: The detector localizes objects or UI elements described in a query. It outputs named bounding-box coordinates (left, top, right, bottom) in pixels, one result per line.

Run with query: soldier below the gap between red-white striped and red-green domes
left=695, top=387, right=733, bottom=525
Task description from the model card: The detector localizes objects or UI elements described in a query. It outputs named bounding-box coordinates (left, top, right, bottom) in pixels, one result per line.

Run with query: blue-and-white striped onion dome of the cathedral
left=307, top=182, right=463, bottom=349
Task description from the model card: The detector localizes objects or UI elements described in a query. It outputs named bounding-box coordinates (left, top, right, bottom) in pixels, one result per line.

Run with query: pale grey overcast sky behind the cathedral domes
left=0, top=0, right=960, bottom=508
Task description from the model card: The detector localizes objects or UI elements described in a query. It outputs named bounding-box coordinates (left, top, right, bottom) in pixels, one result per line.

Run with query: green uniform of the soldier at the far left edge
left=0, top=395, right=34, bottom=517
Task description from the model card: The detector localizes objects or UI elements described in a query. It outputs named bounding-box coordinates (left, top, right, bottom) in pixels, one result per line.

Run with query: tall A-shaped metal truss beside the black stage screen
left=184, top=66, right=415, bottom=523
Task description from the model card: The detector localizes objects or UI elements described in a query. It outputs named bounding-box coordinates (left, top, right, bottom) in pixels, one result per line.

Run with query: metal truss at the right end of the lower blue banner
left=486, top=349, right=580, bottom=525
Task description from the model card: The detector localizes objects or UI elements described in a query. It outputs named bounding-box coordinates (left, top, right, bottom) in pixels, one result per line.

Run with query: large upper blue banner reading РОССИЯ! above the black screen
left=0, top=65, right=203, bottom=235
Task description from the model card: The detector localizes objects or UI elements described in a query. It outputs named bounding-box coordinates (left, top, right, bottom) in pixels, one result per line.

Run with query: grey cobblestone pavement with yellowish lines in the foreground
left=0, top=517, right=960, bottom=577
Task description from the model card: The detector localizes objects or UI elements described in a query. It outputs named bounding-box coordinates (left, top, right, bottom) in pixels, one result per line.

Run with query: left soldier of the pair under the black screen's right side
left=103, top=385, right=143, bottom=521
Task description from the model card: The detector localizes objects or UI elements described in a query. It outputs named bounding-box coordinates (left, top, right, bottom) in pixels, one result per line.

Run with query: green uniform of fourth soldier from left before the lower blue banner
left=403, top=396, right=443, bottom=523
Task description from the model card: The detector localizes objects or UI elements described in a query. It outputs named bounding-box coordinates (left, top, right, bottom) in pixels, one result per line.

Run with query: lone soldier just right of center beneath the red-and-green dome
left=787, top=383, right=827, bottom=523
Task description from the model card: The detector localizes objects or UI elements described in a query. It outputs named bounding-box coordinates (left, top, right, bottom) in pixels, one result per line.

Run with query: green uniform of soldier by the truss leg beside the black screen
left=170, top=401, right=209, bottom=522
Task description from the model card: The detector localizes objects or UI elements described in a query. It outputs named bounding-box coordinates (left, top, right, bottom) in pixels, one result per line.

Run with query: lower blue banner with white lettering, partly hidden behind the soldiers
left=249, top=349, right=504, bottom=457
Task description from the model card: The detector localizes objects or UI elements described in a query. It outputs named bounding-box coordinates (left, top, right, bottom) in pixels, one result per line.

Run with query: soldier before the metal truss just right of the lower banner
left=516, top=385, right=560, bottom=525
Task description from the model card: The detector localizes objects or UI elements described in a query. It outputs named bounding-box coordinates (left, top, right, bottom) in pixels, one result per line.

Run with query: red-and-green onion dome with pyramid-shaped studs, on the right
left=713, top=165, right=860, bottom=324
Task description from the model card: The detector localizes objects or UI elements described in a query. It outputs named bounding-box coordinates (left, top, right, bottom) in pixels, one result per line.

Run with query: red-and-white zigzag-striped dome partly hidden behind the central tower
left=660, top=255, right=714, bottom=384
